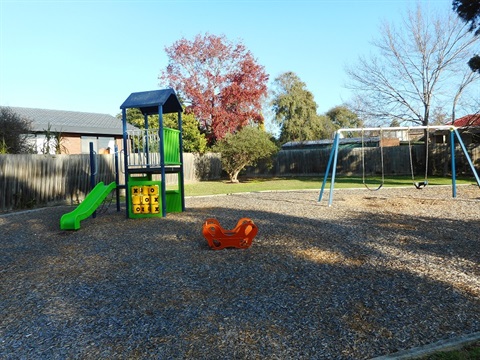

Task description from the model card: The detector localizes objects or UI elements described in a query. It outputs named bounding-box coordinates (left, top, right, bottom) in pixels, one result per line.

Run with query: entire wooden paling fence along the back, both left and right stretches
left=0, top=145, right=480, bottom=212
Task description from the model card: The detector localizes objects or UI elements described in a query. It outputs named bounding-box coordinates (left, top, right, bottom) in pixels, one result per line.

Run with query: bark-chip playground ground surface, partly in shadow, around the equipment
left=0, top=185, right=480, bottom=359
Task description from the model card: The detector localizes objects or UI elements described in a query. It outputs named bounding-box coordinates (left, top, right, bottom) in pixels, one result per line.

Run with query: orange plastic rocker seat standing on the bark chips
left=202, top=218, right=258, bottom=250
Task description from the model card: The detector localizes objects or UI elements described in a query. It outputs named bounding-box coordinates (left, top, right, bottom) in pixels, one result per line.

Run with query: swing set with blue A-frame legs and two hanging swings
left=318, top=125, right=480, bottom=206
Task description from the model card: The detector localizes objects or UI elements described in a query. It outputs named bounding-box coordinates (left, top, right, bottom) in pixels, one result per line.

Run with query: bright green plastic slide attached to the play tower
left=60, top=182, right=117, bottom=230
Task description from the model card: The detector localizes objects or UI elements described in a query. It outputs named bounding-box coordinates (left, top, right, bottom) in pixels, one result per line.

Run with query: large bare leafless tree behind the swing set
left=347, top=5, right=480, bottom=126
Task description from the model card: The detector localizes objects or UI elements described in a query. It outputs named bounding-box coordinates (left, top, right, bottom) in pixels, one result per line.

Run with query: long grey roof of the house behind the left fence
left=3, top=107, right=136, bottom=136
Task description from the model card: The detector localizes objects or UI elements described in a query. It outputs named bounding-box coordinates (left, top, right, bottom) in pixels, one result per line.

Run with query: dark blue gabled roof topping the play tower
left=120, top=89, right=183, bottom=115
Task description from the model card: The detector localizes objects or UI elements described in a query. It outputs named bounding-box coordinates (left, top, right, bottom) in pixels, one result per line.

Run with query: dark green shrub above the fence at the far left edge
left=0, top=107, right=32, bottom=154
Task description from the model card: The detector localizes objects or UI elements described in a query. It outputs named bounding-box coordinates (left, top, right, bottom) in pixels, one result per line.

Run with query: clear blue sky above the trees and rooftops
left=0, top=0, right=451, bottom=120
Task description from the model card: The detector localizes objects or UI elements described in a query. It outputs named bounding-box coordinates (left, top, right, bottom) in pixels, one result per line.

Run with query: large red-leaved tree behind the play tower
left=159, top=33, right=268, bottom=143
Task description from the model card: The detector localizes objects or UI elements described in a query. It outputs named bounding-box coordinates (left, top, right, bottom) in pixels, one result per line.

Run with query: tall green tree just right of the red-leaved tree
left=271, top=72, right=325, bottom=143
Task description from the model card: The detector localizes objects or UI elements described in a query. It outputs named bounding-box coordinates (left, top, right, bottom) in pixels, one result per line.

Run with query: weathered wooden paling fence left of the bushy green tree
left=0, top=153, right=221, bottom=212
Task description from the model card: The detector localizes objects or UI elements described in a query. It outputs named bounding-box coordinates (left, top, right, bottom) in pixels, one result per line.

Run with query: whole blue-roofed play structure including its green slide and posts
left=60, top=89, right=185, bottom=230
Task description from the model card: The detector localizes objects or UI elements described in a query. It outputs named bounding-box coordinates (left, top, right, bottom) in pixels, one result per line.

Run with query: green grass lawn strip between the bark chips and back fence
left=185, top=176, right=475, bottom=196
